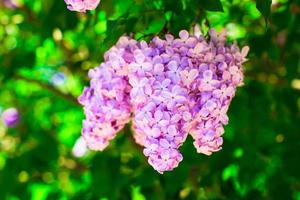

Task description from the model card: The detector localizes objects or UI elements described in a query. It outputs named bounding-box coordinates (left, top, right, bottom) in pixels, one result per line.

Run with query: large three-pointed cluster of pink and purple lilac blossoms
left=79, top=30, right=249, bottom=173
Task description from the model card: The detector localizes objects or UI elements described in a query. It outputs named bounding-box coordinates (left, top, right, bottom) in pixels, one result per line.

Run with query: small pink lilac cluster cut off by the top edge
left=65, top=0, right=100, bottom=12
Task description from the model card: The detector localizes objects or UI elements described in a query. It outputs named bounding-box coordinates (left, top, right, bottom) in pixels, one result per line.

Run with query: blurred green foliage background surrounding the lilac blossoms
left=0, top=0, right=300, bottom=200
